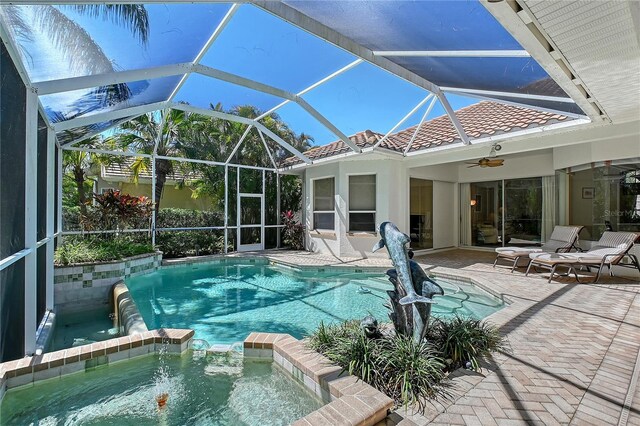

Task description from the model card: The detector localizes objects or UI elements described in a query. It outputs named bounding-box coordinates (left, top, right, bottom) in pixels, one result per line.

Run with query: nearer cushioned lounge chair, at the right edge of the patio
left=525, top=231, right=640, bottom=283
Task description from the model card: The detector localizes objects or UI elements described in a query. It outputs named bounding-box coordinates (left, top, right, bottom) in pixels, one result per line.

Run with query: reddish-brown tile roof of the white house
left=281, top=101, right=571, bottom=167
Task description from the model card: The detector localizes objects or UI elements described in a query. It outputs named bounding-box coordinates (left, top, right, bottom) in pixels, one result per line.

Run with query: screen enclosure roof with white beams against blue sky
left=0, top=0, right=603, bottom=164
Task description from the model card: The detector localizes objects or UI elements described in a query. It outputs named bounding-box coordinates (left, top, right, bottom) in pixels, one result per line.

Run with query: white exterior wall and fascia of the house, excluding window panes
left=304, top=121, right=640, bottom=257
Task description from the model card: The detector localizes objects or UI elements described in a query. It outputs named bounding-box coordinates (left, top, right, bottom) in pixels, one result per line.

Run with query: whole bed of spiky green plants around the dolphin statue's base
left=307, top=316, right=502, bottom=411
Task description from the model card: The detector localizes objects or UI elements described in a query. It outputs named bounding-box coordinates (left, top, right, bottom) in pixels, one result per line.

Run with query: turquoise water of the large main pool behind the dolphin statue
left=126, top=263, right=502, bottom=344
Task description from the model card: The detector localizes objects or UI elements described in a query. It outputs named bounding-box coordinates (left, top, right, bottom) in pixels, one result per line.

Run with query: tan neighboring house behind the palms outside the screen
left=94, top=158, right=216, bottom=210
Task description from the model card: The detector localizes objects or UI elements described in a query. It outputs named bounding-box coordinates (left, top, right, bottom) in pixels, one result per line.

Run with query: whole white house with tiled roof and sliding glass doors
left=284, top=101, right=640, bottom=276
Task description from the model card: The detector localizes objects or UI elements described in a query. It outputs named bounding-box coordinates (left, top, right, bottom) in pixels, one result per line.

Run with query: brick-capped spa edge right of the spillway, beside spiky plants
left=243, top=332, right=394, bottom=426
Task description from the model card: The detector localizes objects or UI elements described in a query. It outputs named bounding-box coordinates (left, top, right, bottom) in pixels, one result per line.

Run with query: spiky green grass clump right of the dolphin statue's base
left=427, top=315, right=502, bottom=371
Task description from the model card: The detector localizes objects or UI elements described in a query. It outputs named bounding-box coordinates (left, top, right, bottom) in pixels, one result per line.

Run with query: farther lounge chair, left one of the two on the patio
left=493, top=226, right=584, bottom=272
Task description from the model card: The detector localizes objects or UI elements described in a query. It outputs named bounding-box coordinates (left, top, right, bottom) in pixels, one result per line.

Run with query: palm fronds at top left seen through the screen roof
left=0, top=4, right=149, bottom=120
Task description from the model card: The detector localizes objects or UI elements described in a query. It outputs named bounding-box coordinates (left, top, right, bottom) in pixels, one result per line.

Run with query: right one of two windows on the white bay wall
left=349, top=175, right=376, bottom=232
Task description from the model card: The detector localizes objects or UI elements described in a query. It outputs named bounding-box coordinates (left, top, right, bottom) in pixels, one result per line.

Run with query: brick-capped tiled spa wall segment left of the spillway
left=0, top=328, right=194, bottom=402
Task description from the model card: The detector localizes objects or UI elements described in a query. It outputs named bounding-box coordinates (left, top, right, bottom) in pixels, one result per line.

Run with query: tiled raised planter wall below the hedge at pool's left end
left=53, top=252, right=162, bottom=309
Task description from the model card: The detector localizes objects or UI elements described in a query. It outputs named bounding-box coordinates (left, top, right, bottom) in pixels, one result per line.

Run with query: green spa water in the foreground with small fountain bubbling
left=0, top=352, right=322, bottom=426
